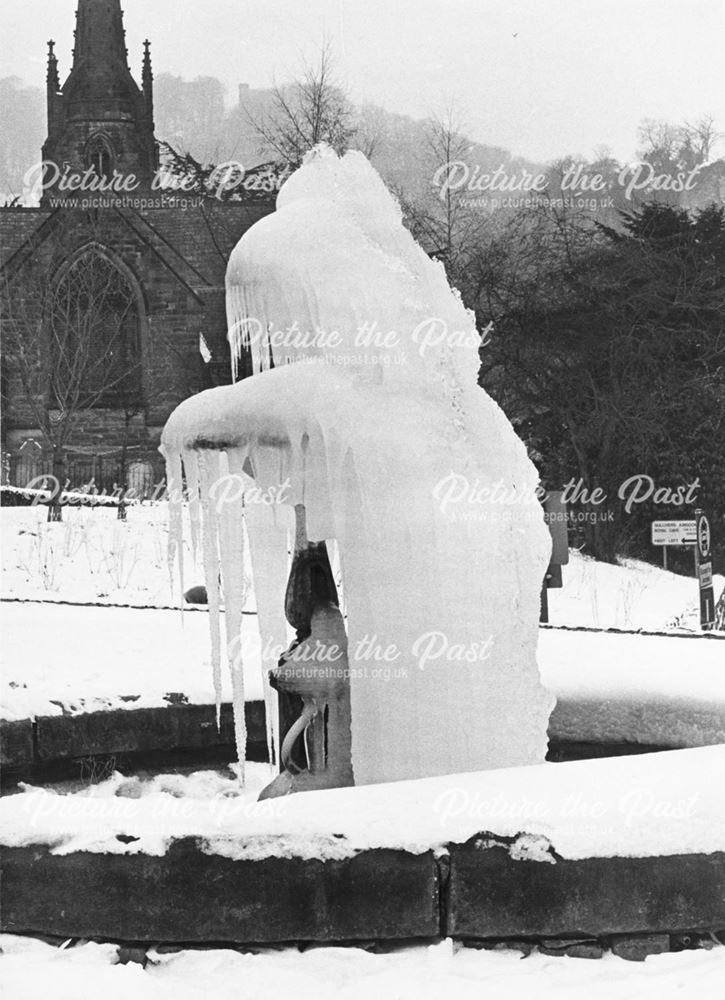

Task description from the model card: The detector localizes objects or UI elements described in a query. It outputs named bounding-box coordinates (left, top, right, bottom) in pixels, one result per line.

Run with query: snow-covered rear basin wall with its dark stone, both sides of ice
left=0, top=602, right=725, bottom=781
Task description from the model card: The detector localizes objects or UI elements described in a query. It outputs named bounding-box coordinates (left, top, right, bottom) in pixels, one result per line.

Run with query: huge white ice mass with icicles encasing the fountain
left=162, top=148, right=553, bottom=785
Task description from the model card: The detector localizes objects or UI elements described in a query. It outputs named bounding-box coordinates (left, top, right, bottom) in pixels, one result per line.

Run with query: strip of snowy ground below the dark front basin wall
left=0, top=935, right=725, bottom=1000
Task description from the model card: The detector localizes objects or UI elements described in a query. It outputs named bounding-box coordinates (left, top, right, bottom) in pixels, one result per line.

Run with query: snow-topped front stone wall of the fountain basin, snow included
left=0, top=746, right=725, bottom=943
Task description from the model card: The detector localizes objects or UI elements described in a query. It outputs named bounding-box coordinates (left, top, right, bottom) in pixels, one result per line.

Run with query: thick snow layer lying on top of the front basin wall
left=0, top=746, right=725, bottom=864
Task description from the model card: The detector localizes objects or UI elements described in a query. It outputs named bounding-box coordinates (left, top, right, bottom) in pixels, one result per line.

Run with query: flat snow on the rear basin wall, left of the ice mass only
left=0, top=602, right=263, bottom=719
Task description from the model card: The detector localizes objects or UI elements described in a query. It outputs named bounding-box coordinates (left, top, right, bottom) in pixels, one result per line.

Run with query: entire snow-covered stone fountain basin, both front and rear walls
left=0, top=605, right=725, bottom=953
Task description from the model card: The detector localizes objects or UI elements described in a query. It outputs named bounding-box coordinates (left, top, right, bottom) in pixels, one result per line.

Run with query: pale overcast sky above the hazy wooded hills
left=0, top=0, right=725, bottom=160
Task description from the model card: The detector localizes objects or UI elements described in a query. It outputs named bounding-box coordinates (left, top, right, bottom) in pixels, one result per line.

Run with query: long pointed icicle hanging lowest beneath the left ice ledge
left=217, top=451, right=247, bottom=784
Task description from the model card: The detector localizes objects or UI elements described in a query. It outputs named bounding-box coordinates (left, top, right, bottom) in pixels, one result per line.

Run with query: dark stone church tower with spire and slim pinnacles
left=43, top=0, right=158, bottom=203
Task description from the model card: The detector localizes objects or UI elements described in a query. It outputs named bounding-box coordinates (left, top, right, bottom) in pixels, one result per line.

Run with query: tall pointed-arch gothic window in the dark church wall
left=49, top=248, right=141, bottom=410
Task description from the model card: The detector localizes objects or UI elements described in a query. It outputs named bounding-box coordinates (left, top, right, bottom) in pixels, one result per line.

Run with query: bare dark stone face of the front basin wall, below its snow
left=1, top=835, right=725, bottom=957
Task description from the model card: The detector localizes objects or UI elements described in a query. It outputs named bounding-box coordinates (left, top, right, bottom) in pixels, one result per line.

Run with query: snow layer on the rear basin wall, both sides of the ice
left=0, top=602, right=725, bottom=747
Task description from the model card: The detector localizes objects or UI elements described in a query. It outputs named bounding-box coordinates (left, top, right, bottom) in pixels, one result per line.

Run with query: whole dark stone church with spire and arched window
left=0, top=0, right=274, bottom=488
